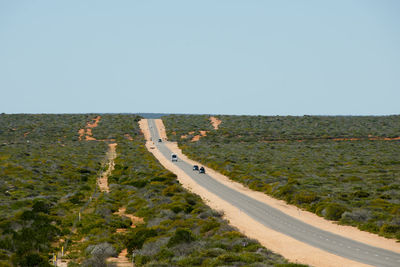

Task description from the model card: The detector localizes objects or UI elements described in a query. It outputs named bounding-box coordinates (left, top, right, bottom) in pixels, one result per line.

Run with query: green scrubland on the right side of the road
left=163, top=115, right=400, bottom=240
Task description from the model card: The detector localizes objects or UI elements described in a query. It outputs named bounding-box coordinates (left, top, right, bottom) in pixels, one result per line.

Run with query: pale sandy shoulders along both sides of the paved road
left=139, top=120, right=400, bottom=266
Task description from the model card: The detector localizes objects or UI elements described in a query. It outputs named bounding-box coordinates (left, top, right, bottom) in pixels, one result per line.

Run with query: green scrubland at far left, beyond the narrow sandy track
left=0, top=114, right=106, bottom=266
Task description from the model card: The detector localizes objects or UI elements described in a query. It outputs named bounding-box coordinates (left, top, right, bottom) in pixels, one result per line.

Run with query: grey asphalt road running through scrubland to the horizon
left=148, top=119, right=400, bottom=267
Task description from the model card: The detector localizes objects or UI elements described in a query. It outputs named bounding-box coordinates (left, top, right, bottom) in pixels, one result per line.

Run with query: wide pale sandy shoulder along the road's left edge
left=139, top=119, right=369, bottom=267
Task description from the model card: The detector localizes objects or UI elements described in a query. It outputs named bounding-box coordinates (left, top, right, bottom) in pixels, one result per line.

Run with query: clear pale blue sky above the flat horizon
left=0, top=0, right=400, bottom=115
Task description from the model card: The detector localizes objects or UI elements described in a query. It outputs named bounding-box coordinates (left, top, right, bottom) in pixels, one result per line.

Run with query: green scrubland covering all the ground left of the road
left=0, top=114, right=298, bottom=266
